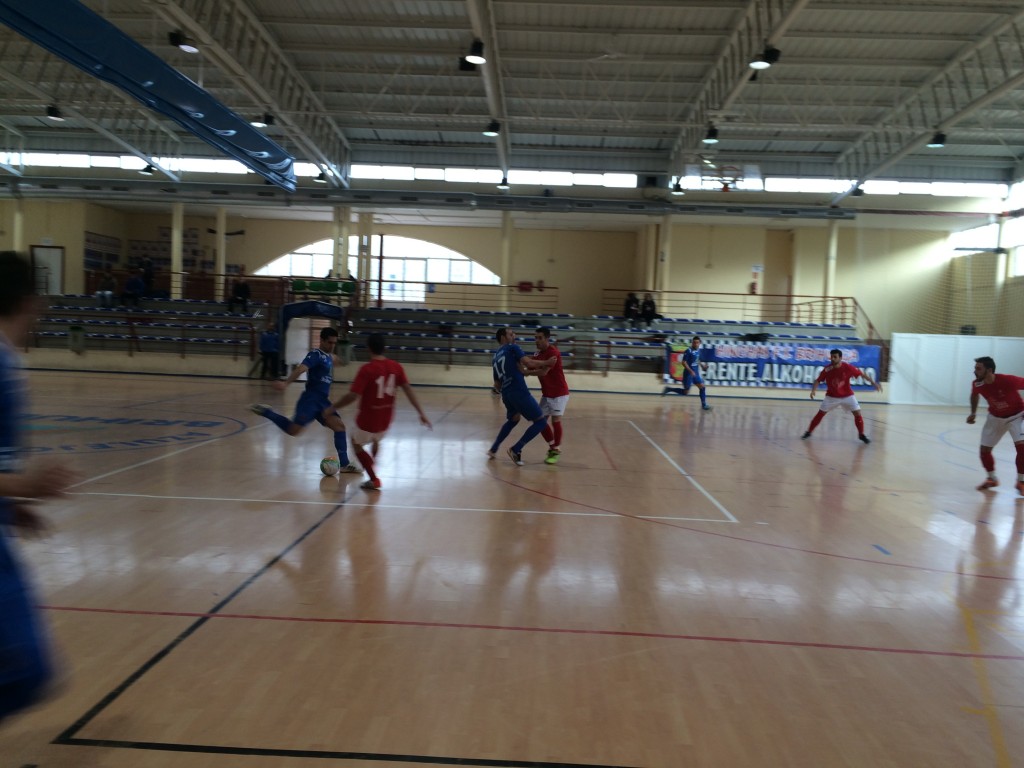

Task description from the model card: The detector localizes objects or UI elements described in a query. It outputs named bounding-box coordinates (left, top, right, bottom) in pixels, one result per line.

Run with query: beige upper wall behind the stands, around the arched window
left=0, top=200, right=1007, bottom=337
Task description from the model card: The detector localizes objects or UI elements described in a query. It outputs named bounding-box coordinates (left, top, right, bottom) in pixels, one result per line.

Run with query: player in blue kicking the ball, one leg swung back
left=250, top=328, right=362, bottom=474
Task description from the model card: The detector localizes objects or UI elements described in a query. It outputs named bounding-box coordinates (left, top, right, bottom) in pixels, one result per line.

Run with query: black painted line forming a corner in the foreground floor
left=51, top=488, right=627, bottom=768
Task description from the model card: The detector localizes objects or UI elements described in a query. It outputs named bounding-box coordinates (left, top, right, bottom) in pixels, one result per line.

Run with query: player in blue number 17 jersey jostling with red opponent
left=487, top=328, right=550, bottom=467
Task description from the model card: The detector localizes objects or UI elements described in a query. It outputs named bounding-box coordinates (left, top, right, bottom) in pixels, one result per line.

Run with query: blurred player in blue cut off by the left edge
left=0, top=251, right=74, bottom=721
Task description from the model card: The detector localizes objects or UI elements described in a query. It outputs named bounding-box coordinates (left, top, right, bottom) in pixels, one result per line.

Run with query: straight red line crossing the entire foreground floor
left=39, top=605, right=1024, bottom=662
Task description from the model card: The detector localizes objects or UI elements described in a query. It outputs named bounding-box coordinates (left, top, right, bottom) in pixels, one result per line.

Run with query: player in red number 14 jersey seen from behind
left=325, top=334, right=433, bottom=490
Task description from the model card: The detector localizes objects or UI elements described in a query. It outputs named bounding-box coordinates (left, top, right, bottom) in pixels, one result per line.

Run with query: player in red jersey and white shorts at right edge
left=967, top=357, right=1024, bottom=496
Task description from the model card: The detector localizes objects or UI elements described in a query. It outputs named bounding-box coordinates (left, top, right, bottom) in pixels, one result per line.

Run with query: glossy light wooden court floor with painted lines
left=0, top=371, right=1024, bottom=768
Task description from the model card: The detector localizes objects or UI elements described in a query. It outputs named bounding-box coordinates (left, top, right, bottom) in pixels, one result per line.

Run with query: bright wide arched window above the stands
left=255, top=234, right=501, bottom=303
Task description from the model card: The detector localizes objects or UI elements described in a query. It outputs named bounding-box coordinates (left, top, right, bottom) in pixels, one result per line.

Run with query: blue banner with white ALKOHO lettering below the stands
left=666, top=338, right=881, bottom=391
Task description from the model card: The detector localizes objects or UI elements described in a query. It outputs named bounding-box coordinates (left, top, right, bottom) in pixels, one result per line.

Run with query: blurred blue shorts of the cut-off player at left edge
left=0, top=534, right=51, bottom=720
